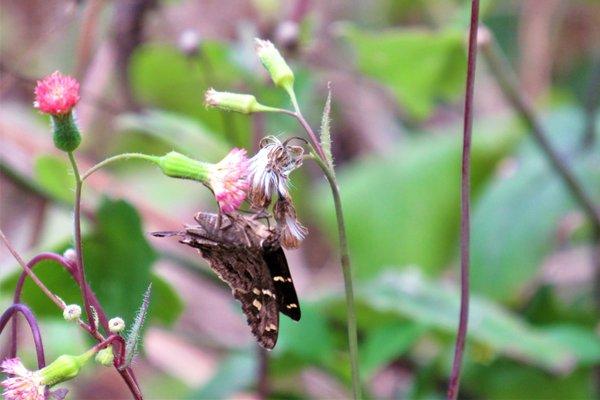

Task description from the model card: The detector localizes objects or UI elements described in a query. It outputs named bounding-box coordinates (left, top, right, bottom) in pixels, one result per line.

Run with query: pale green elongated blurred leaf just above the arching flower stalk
left=117, top=110, right=229, bottom=161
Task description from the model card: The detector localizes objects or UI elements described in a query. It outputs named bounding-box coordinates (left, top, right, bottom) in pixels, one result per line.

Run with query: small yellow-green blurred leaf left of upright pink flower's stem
left=33, top=155, right=75, bottom=204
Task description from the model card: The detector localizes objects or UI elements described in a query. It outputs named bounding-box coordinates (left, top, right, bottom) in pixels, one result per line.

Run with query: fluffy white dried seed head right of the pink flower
left=248, top=136, right=304, bottom=208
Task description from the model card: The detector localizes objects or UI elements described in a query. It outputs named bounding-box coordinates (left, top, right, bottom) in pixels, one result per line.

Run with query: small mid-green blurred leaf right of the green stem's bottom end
left=360, top=321, right=427, bottom=377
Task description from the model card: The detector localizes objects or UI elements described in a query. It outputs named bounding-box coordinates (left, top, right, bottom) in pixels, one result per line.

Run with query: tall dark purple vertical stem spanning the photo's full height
left=447, top=0, right=479, bottom=400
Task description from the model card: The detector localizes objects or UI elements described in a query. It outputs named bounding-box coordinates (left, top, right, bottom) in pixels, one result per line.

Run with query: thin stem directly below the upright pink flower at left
left=67, top=152, right=98, bottom=334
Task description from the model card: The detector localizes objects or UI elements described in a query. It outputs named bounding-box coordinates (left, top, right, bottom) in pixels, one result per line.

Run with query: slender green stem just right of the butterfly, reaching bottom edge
left=314, top=152, right=361, bottom=399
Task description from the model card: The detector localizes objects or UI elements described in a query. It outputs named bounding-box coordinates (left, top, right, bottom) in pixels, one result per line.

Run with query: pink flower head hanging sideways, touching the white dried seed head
left=209, top=148, right=250, bottom=213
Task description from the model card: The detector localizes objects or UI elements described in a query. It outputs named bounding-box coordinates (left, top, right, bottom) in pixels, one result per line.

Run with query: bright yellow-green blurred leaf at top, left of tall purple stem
left=344, top=27, right=466, bottom=118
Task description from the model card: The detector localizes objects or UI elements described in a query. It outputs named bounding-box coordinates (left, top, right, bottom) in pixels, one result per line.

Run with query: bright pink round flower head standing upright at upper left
left=33, top=71, right=79, bottom=115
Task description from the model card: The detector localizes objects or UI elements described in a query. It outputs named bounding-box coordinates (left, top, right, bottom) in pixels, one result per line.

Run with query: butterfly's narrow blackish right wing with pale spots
left=263, top=247, right=300, bottom=321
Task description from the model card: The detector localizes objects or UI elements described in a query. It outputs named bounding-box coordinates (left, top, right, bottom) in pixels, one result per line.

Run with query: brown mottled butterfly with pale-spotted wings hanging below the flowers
left=155, top=212, right=301, bottom=349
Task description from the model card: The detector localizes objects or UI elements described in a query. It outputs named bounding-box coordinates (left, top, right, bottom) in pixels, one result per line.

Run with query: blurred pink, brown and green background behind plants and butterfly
left=0, top=0, right=600, bottom=399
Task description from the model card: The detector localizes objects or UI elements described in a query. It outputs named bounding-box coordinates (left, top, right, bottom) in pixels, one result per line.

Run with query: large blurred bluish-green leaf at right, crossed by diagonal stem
left=471, top=110, right=600, bottom=302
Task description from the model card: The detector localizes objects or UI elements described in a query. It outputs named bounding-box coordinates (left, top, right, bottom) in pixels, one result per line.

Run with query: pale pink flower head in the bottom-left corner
left=0, top=358, right=46, bottom=400
